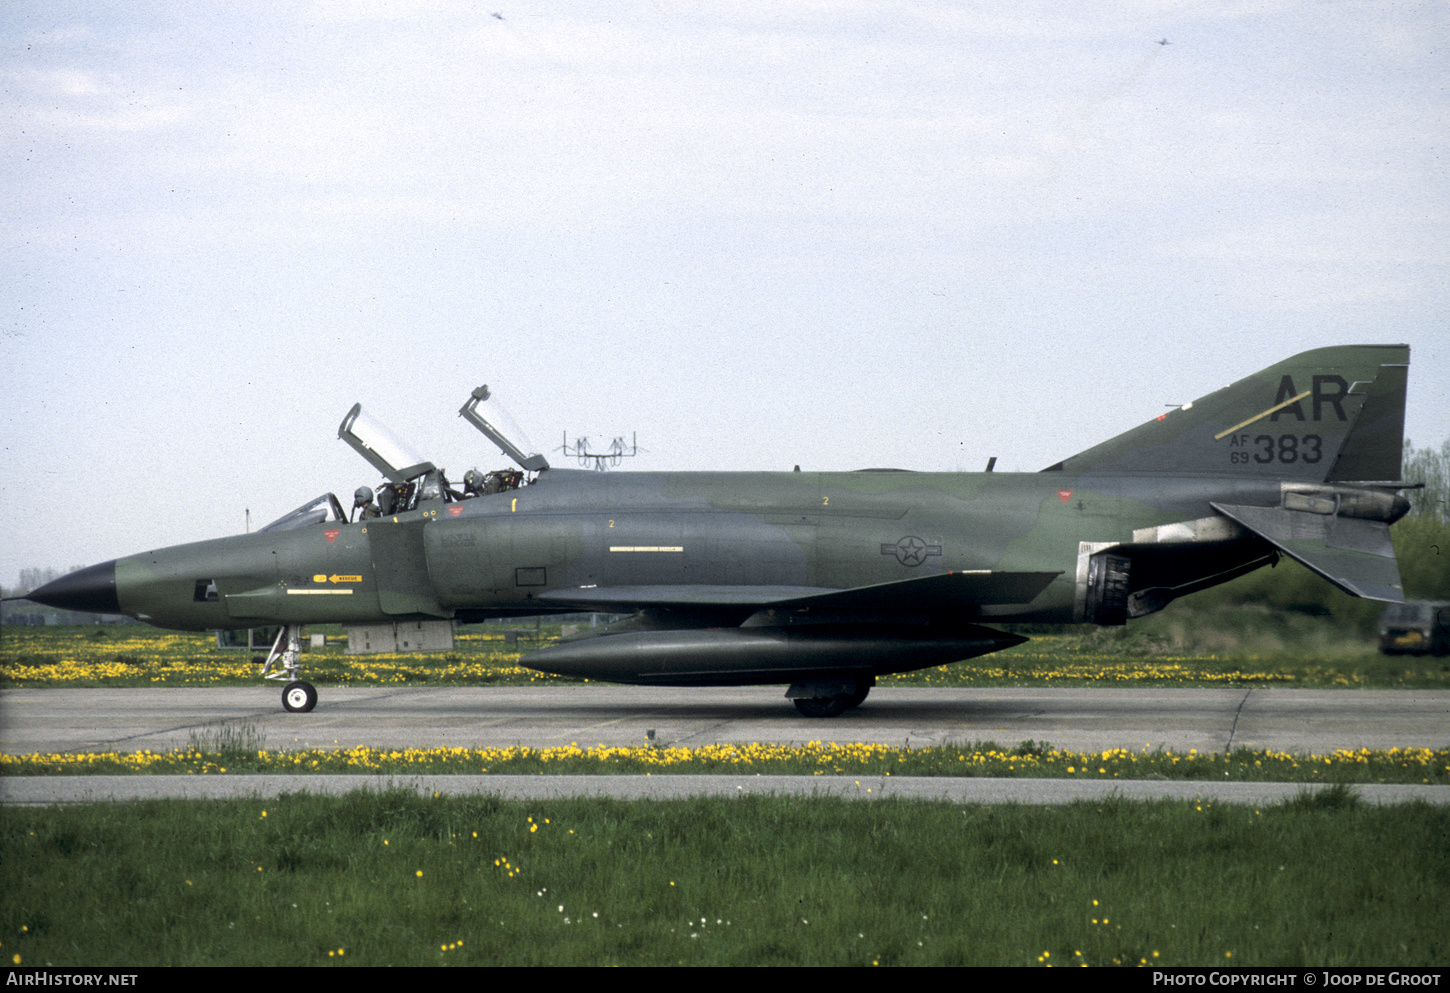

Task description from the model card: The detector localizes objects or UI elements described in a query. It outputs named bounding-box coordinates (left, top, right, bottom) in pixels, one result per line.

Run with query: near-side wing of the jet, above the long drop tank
left=539, top=570, right=1061, bottom=610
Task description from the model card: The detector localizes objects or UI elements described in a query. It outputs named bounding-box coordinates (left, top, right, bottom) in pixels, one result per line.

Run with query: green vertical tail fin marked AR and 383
left=1043, top=345, right=1409, bottom=483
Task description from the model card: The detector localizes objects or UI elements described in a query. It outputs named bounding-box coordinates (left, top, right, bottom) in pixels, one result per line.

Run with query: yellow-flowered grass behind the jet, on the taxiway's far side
left=8, top=607, right=1450, bottom=689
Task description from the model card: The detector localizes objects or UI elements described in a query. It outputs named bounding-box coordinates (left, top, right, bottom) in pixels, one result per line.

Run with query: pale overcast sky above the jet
left=0, top=0, right=1450, bottom=583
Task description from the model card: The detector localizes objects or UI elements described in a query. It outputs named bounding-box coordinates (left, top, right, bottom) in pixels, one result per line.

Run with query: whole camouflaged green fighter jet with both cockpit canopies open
left=17, top=345, right=1409, bottom=718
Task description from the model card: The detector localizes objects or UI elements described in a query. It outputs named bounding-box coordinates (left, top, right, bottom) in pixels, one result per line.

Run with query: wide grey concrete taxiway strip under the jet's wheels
left=0, top=686, right=1450, bottom=754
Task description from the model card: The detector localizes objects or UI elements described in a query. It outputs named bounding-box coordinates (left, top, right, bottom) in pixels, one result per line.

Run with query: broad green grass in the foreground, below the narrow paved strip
left=0, top=790, right=1450, bottom=965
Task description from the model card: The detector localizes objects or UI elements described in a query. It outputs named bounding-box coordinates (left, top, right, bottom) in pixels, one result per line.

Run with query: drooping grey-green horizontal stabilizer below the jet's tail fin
left=1209, top=503, right=1405, bottom=603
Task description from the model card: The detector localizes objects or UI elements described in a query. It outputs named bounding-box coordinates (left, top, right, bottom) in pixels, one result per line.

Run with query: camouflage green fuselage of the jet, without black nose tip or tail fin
left=116, top=470, right=1279, bottom=629
